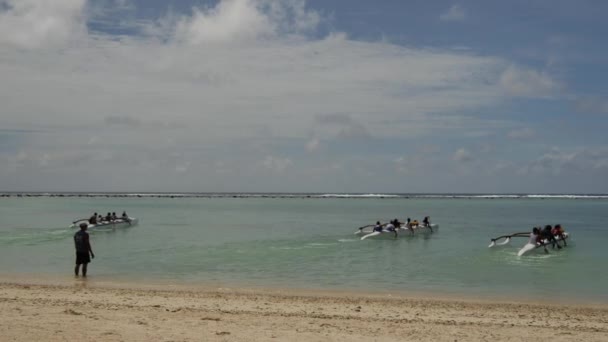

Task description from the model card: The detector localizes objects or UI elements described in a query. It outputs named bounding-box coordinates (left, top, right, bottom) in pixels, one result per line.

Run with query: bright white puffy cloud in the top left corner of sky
left=0, top=0, right=86, bottom=49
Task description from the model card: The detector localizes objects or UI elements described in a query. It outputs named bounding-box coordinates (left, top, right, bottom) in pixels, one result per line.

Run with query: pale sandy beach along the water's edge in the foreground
left=0, top=280, right=608, bottom=341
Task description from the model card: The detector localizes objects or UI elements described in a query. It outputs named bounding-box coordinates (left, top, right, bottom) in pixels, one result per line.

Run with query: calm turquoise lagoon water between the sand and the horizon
left=0, top=196, right=608, bottom=302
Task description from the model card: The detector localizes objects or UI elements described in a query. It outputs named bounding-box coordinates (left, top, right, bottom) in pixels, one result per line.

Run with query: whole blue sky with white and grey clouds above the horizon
left=0, top=0, right=608, bottom=193
